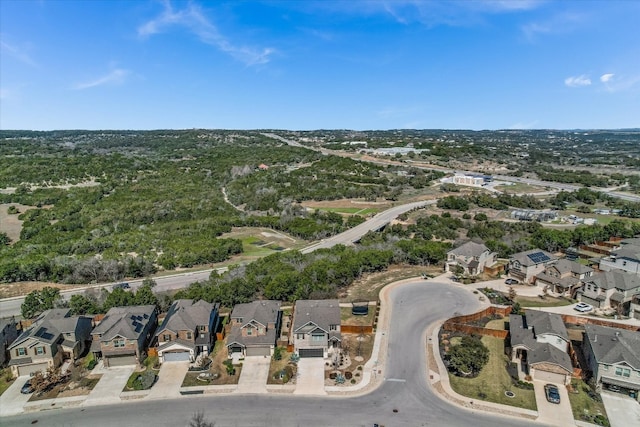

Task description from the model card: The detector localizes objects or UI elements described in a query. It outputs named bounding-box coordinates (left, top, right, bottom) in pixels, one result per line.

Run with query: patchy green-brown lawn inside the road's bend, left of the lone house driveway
left=449, top=337, right=537, bottom=411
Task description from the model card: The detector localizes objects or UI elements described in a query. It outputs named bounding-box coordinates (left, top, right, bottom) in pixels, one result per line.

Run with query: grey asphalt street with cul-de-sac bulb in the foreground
left=1, top=281, right=540, bottom=427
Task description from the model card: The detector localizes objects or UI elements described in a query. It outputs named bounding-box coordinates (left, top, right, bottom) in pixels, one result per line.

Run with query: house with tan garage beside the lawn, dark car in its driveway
left=509, top=310, right=573, bottom=384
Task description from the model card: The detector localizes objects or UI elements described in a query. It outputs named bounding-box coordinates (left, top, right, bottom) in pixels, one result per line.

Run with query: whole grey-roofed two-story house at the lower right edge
left=582, top=324, right=640, bottom=401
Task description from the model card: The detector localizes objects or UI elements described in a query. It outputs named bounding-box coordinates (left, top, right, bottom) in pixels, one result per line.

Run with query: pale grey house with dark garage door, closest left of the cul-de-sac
left=290, top=299, right=342, bottom=358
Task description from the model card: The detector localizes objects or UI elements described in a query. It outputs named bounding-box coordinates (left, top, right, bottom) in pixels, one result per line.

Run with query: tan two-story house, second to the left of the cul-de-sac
left=227, top=300, right=282, bottom=358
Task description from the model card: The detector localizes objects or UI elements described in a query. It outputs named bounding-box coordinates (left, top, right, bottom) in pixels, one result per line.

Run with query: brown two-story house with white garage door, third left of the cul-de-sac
left=156, top=299, right=220, bottom=362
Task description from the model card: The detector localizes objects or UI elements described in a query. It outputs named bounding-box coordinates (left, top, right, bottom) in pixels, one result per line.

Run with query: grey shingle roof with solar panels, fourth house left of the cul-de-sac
left=91, top=305, right=156, bottom=341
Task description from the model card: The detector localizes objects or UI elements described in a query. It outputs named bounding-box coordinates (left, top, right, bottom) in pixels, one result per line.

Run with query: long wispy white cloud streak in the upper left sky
left=138, top=1, right=275, bottom=65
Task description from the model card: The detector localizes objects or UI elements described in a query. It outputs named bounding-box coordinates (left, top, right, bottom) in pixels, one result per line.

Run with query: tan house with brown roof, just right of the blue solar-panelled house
left=535, top=259, right=594, bottom=298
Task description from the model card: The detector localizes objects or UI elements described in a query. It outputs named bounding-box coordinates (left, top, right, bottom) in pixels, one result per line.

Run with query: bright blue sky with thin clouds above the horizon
left=0, top=0, right=640, bottom=130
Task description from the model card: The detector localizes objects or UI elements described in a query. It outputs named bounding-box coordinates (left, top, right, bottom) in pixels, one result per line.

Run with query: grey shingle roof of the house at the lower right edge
left=584, top=324, right=640, bottom=370
